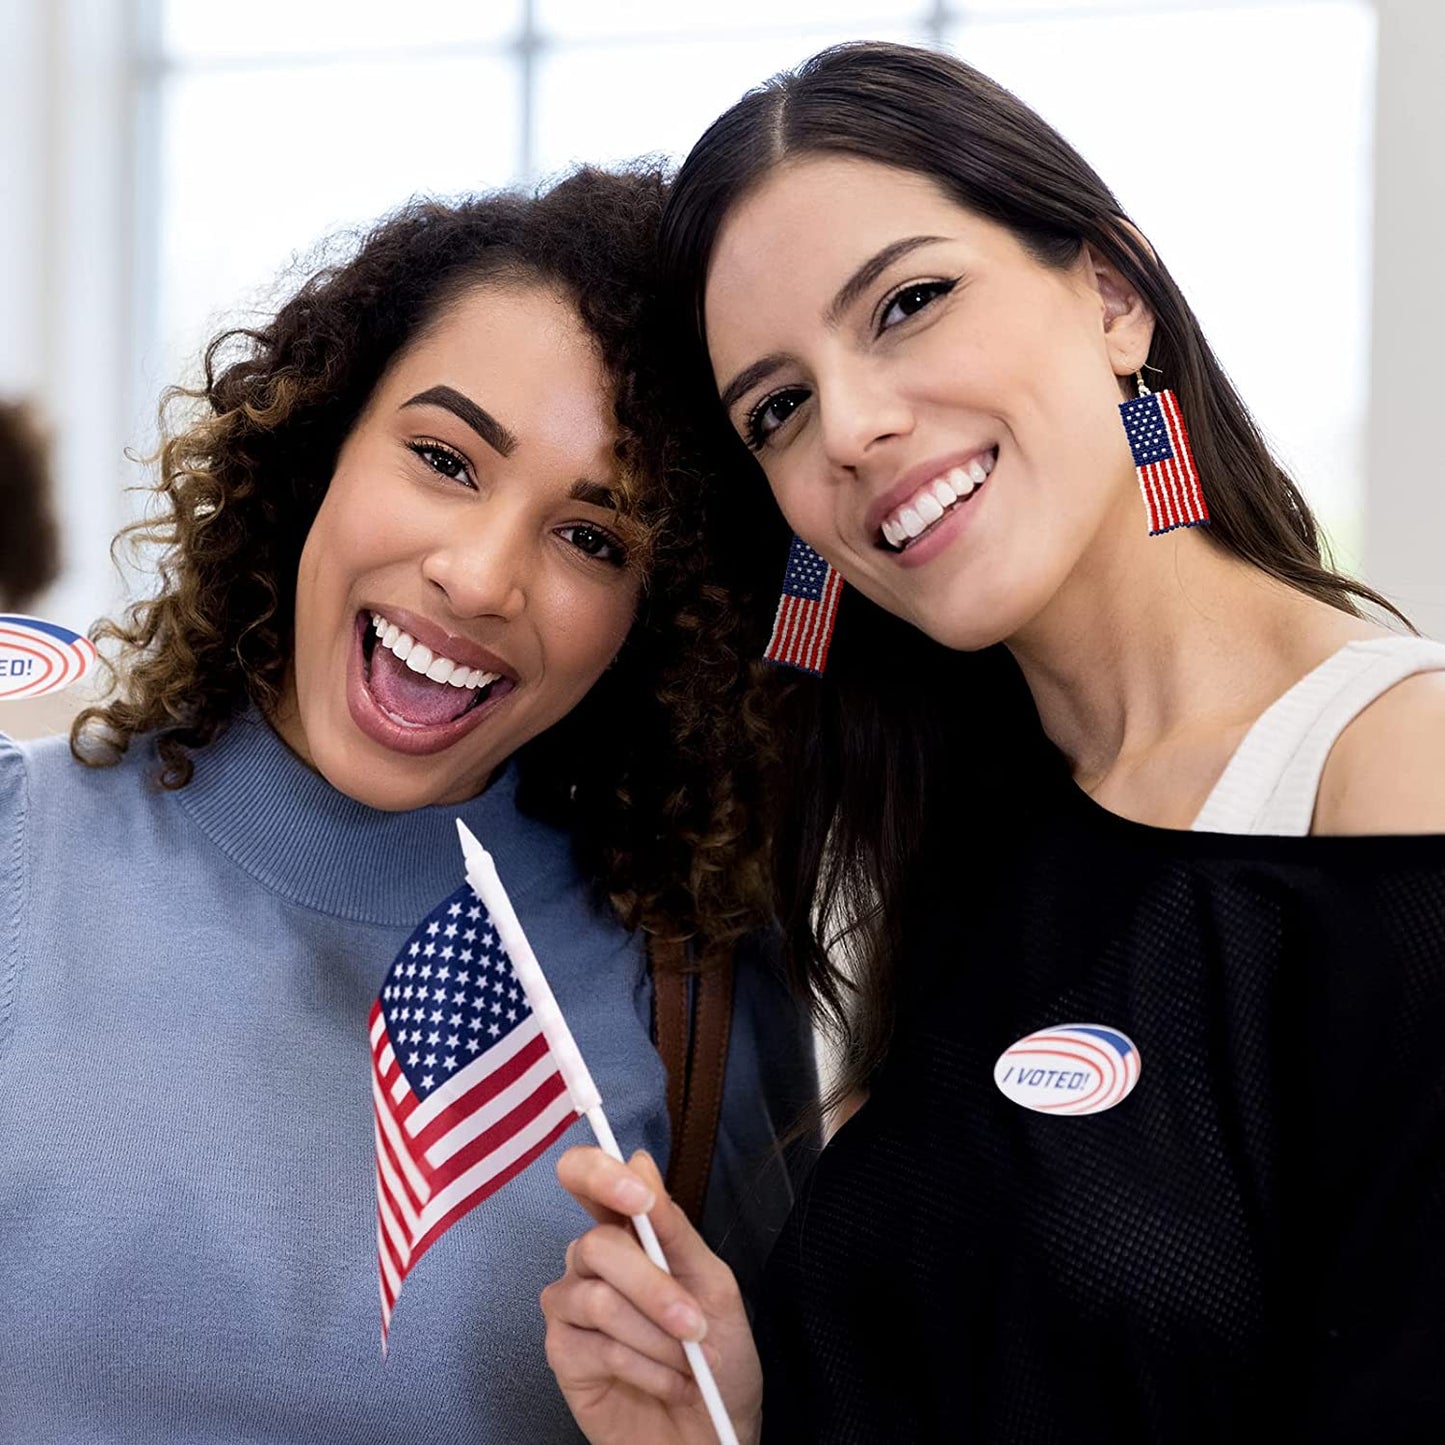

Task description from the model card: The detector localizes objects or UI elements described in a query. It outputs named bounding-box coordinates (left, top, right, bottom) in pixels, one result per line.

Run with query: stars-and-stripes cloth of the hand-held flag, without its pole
left=371, top=886, right=578, bottom=1347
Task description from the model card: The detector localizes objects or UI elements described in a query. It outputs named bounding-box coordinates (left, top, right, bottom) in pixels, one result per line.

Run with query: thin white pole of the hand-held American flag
left=457, top=818, right=738, bottom=1445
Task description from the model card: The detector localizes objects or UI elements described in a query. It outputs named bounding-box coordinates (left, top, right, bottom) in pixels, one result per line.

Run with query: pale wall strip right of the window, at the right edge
left=1364, top=0, right=1445, bottom=639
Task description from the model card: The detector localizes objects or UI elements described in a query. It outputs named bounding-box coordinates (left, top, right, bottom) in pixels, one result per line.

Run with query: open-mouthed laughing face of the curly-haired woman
left=275, top=285, right=640, bottom=811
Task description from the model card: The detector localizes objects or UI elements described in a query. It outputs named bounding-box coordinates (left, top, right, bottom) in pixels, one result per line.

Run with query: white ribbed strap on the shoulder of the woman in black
left=1194, top=637, right=1445, bottom=837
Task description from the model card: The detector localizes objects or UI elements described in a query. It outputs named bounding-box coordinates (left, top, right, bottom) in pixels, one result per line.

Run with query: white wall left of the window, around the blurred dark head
left=0, top=0, right=140, bottom=630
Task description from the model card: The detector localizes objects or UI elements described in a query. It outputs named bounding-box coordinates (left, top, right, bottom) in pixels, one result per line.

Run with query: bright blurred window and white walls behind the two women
left=0, top=0, right=1445, bottom=725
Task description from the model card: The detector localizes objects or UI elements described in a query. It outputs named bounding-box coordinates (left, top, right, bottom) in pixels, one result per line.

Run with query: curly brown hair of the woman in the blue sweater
left=71, top=166, right=767, bottom=967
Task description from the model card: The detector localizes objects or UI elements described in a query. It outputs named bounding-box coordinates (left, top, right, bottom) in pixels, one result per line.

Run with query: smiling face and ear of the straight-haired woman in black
left=705, top=156, right=1152, bottom=649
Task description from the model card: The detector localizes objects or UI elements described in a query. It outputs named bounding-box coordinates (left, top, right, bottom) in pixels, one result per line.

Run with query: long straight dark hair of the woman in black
left=662, top=43, right=1403, bottom=1094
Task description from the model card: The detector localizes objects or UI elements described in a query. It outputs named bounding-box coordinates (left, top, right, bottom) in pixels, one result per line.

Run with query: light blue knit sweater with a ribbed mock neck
left=0, top=715, right=811, bottom=1445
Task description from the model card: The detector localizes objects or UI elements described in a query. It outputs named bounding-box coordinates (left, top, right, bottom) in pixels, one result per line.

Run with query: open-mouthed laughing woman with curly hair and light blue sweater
left=0, top=164, right=811, bottom=1445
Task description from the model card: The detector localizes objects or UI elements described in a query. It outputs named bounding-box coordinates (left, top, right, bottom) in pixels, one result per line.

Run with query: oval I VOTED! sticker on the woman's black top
left=994, top=1023, right=1139, bottom=1114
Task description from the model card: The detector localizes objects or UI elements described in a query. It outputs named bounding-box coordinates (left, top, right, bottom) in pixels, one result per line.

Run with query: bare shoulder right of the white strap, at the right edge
left=1314, top=672, right=1445, bottom=834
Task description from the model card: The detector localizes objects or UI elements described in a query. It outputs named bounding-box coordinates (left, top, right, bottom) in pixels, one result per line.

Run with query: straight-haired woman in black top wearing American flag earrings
left=545, top=45, right=1445, bottom=1445
